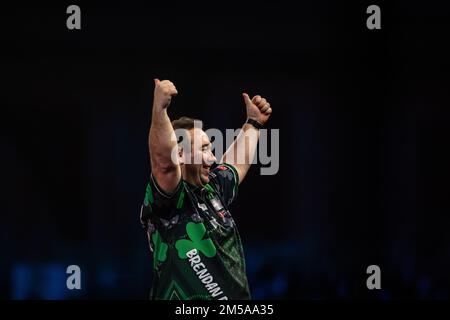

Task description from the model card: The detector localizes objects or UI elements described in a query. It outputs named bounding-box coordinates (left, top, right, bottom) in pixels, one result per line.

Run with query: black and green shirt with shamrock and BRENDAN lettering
left=141, top=164, right=250, bottom=300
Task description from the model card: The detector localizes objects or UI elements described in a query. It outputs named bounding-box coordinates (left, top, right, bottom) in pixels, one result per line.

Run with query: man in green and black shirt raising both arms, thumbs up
left=141, top=79, right=272, bottom=300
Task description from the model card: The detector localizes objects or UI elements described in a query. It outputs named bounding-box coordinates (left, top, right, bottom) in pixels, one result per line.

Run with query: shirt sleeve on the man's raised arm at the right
left=210, top=163, right=239, bottom=205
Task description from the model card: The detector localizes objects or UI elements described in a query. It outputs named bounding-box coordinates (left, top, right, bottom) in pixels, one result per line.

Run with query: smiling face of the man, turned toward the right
left=185, top=128, right=217, bottom=186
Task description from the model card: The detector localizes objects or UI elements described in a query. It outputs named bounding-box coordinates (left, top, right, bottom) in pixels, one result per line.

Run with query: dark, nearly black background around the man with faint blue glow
left=0, top=0, right=450, bottom=299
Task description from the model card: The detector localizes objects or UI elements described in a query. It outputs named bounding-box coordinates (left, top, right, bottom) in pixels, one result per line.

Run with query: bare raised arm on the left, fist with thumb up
left=148, top=79, right=181, bottom=194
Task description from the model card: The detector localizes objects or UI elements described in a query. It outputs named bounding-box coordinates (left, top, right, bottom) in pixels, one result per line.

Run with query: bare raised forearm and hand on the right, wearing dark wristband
left=220, top=93, right=272, bottom=184
